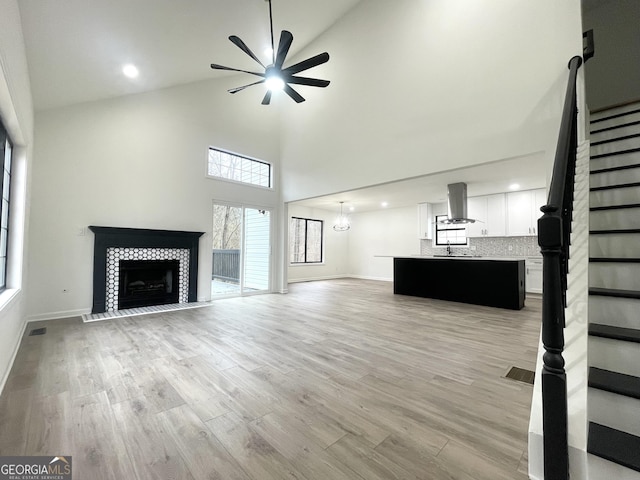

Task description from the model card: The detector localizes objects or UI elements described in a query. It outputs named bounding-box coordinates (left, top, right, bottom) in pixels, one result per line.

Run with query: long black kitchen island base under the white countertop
left=393, top=257, right=525, bottom=310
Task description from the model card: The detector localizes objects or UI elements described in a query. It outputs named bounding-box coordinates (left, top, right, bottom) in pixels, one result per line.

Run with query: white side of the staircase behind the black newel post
left=529, top=140, right=590, bottom=480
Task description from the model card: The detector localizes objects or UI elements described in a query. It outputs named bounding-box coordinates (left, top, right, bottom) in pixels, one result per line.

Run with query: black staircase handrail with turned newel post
left=538, top=56, right=582, bottom=480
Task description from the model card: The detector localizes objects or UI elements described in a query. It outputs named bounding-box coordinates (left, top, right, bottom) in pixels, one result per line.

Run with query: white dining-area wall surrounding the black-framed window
left=286, top=204, right=351, bottom=282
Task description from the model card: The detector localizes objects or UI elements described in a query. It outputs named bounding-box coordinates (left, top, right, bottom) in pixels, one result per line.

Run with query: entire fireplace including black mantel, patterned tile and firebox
left=89, top=226, right=204, bottom=313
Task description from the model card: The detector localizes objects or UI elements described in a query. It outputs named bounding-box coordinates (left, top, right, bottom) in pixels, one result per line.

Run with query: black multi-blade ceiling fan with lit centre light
left=211, top=0, right=329, bottom=105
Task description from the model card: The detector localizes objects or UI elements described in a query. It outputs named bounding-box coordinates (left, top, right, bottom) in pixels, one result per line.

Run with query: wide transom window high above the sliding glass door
left=207, top=147, right=271, bottom=188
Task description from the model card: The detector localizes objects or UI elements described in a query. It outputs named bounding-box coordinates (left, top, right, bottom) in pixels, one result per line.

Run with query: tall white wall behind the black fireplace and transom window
left=28, top=79, right=282, bottom=319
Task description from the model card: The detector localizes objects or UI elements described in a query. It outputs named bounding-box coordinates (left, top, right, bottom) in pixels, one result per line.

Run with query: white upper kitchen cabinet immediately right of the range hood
left=467, top=193, right=506, bottom=238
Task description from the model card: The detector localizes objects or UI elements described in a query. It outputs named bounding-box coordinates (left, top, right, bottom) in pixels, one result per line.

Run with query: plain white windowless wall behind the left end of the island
left=349, top=205, right=420, bottom=281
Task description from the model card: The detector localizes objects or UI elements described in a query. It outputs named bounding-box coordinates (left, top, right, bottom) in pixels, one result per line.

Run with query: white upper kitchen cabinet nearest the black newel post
left=507, top=188, right=546, bottom=237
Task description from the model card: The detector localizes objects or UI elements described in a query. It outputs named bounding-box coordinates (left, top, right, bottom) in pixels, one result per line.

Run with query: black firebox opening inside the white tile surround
left=118, top=260, right=180, bottom=310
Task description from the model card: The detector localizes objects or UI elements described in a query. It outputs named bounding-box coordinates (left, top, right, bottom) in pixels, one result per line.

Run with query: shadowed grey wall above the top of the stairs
left=583, top=0, right=640, bottom=110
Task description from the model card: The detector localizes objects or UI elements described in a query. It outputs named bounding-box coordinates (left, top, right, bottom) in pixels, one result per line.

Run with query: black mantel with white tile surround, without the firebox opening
left=89, top=225, right=204, bottom=314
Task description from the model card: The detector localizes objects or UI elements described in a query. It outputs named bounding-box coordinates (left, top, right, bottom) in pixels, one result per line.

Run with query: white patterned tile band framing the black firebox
left=106, top=247, right=189, bottom=312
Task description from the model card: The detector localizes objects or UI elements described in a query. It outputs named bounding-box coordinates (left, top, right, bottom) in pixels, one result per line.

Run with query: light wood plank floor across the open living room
left=0, top=279, right=540, bottom=480
